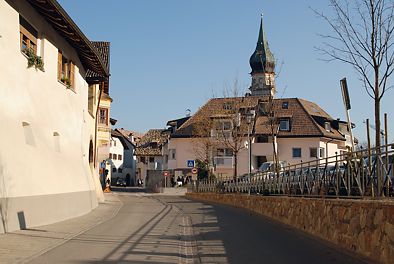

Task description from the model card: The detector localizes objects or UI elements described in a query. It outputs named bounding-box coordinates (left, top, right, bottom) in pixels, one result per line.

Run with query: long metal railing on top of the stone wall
left=193, top=145, right=394, bottom=197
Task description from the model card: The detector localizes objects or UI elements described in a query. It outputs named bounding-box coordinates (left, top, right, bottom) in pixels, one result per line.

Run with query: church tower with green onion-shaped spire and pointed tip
left=249, top=16, right=276, bottom=96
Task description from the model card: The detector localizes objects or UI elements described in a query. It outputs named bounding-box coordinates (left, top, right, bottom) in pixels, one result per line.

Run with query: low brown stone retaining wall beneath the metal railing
left=186, top=193, right=394, bottom=263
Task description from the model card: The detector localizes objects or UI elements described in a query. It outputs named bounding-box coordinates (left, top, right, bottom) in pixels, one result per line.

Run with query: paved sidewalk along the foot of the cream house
left=0, top=193, right=122, bottom=263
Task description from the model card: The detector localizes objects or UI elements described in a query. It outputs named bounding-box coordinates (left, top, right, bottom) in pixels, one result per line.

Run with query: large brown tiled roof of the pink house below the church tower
left=171, top=96, right=345, bottom=140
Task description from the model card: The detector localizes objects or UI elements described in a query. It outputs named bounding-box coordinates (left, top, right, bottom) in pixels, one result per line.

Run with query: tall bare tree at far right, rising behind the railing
left=314, top=0, right=394, bottom=153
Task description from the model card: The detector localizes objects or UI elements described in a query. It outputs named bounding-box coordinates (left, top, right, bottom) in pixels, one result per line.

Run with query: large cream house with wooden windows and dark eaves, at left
left=0, top=0, right=109, bottom=232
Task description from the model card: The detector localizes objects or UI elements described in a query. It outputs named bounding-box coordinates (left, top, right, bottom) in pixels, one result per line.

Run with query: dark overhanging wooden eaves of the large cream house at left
left=27, top=0, right=109, bottom=78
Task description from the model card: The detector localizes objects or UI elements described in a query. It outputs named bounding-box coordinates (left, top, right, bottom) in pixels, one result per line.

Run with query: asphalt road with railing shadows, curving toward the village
left=30, top=193, right=368, bottom=264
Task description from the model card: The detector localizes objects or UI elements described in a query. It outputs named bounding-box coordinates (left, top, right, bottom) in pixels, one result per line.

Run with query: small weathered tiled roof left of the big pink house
left=136, top=129, right=168, bottom=156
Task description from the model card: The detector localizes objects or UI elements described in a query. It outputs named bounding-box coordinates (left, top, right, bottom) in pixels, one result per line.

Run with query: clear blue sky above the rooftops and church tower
left=59, top=0, right=394, bottom=144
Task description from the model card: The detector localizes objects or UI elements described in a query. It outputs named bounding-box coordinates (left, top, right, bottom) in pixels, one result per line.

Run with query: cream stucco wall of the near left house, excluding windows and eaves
left=0, top=0, right=97, bottom=231
